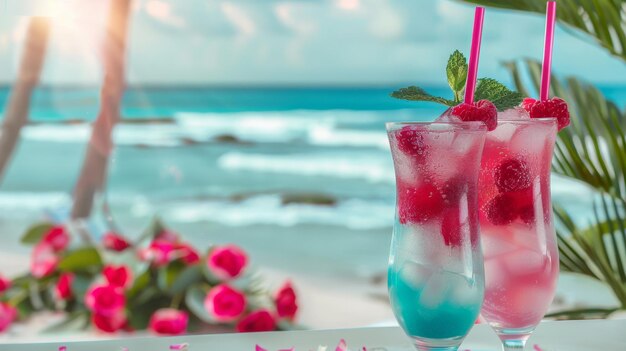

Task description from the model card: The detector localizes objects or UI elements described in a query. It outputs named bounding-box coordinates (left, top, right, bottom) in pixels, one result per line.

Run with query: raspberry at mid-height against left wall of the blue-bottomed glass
left=398, top=183, right=444, bottom=224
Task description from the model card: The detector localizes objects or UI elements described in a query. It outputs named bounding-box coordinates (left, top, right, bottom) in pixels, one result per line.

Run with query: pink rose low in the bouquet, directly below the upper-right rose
left=204, top=284, right=246, bottom=322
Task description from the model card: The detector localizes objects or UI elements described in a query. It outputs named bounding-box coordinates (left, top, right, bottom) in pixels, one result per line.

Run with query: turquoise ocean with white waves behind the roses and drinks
left=0, top=87, right=626, bottom=284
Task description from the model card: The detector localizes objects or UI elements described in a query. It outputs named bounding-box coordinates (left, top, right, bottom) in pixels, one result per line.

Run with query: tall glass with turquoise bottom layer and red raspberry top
left=387, top=122, right=486, bottom=350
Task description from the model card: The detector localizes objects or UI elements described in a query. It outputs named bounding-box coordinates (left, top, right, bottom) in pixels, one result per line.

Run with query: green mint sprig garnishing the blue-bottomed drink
left=391, top=50, right=524, bottom=111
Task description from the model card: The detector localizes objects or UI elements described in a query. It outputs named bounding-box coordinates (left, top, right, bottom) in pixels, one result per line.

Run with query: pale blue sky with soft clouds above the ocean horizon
left=0, top=0, right=626, bottom=85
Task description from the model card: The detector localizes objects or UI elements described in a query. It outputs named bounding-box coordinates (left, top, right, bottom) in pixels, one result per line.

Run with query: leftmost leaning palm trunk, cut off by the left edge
left=0, top=17, right=50, bottom=181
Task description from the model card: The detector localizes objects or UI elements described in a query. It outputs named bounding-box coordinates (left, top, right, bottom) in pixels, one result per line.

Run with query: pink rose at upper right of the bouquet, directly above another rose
left=207, top=245, right=248, bottom=280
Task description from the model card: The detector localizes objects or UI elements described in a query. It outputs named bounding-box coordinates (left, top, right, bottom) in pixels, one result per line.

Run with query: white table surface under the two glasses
left=0, top=320, right=626, bottom=351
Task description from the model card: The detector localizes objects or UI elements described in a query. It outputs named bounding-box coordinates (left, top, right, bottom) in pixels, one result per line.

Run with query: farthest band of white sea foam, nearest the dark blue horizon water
left=22, top=111, right=389, bottom=149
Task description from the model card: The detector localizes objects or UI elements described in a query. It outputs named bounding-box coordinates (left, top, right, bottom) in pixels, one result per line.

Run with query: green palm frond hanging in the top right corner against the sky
left=462, top=0, right=626, bottom=61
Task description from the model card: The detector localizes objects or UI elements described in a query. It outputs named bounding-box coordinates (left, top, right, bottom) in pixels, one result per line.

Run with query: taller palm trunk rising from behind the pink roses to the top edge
left=71, top=0, right=131, bottom=219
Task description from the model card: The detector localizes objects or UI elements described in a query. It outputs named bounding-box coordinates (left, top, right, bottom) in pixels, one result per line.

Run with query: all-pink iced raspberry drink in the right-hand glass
left=479, top=117, right=559, bottom=338
